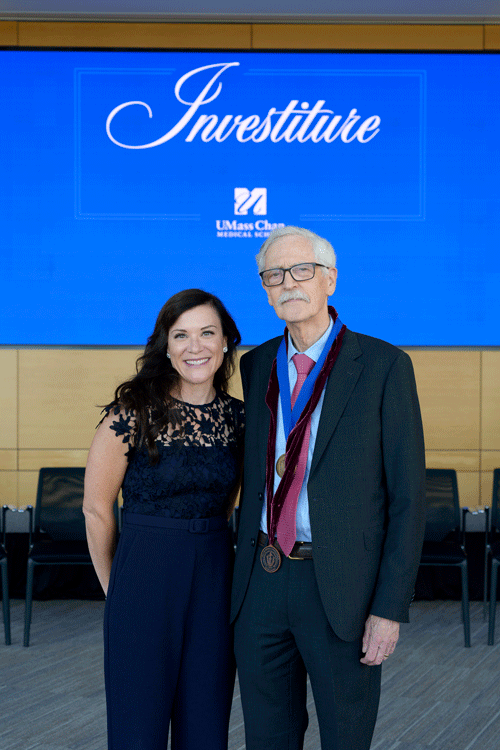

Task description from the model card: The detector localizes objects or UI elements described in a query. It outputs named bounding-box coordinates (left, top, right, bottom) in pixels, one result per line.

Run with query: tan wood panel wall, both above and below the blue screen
left=0, top=21, right=500, bottom=507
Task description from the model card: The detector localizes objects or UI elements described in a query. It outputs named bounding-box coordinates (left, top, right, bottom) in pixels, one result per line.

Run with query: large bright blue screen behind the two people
left=0, top=50, right=500, bottom=346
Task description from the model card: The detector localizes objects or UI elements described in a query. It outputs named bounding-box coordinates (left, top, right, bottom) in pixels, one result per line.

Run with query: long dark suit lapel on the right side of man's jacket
left=310, top=330, right=363, bottom=476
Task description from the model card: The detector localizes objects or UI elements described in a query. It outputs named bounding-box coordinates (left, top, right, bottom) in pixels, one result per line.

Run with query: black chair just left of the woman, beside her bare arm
left=24, top=467, right=92, bottom=646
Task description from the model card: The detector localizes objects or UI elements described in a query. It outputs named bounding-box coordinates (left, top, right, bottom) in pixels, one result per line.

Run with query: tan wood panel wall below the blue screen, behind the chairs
left=0, top=350, right=500, bottom=507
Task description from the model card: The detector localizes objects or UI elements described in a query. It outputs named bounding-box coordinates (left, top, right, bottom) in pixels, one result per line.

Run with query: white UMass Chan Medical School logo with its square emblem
left=215, top=188, right=285, bottom=239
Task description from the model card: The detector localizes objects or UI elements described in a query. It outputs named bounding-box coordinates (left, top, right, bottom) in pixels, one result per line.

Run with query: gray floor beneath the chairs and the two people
left=0, top=600, right=500, bottom=750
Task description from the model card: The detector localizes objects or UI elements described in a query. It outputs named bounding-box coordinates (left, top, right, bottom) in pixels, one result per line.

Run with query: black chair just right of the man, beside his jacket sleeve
left=420, top=469, right=470, bottom=647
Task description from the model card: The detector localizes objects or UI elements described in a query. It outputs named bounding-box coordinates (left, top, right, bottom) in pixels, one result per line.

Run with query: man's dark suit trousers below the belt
left=235, top=549, right=381, bottom=750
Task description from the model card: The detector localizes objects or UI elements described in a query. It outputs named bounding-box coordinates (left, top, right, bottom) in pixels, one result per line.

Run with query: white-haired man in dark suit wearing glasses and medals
left=232, top=227, right=425, bottom=750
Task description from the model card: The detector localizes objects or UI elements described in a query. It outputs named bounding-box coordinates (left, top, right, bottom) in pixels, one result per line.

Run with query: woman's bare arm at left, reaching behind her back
left=83, top=412, right=128, bottom=594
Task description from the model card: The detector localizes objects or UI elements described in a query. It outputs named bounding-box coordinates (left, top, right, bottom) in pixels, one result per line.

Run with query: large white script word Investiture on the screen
left=106, top=62, right=381, bottom=149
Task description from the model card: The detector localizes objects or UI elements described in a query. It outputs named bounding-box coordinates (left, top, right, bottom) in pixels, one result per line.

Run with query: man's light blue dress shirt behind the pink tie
left=260, top=318, right=333, bottom=542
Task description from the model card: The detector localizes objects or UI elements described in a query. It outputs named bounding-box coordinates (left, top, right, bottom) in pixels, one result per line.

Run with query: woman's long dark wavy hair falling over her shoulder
left=106, top=289, right=241, bottom=463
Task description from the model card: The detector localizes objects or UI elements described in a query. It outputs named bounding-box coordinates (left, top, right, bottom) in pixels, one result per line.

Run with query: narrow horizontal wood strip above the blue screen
left=4, top=21, right=492, bottom=51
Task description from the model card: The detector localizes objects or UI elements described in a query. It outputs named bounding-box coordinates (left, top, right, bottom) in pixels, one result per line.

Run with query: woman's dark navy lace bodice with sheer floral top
left=109, top=393, right=244, bottom=518
